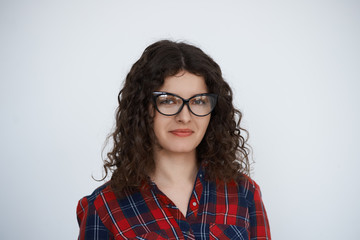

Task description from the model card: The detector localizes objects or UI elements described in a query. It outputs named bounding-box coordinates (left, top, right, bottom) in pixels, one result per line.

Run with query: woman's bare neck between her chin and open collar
left=151, top=150, right=198, bottom=186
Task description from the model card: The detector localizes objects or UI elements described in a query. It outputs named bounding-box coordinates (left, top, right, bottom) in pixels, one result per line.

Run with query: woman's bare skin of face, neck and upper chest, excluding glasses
left=150, top=71, right=210, bottom=216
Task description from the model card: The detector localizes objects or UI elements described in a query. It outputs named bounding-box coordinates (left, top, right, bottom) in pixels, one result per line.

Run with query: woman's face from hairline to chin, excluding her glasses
left=154, top=71, right=210, bottom=153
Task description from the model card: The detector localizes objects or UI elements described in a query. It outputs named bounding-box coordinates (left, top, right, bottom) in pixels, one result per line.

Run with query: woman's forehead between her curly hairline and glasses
left=158, top=71, right=208, bottom=98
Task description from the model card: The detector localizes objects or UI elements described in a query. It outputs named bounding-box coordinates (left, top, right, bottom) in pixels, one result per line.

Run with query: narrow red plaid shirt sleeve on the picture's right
left=248, top=181, right=271, bottom=240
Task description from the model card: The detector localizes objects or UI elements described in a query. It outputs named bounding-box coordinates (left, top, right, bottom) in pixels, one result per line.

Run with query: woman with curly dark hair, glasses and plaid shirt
left=77, top=40, right=271, bottom=239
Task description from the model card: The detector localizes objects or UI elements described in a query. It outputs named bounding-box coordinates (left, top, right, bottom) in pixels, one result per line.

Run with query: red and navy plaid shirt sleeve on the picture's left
left=76, top=197, right=114, bottom=240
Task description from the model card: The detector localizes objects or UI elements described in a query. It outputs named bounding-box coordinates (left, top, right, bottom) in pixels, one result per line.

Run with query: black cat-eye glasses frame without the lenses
left=153, top=92, right=218, bottom=117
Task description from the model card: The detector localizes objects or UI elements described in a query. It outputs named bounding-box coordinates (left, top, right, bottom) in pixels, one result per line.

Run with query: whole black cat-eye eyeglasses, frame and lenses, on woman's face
left=153, top=92, right=217, bottom=117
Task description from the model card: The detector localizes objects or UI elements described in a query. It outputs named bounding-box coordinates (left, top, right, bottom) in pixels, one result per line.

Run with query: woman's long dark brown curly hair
left=104, top=40, right=250, bottom=193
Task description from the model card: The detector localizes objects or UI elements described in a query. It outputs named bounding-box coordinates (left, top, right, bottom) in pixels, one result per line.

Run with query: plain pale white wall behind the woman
left=0, top=0, right=360, bottom=240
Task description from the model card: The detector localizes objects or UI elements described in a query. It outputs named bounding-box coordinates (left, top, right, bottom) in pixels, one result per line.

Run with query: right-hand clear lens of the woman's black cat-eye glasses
left=189, top=95, right=216, bottom=116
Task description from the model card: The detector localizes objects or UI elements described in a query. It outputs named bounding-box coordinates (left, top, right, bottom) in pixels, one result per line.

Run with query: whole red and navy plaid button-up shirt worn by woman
left=77, top=170, right=271, bottom=240
